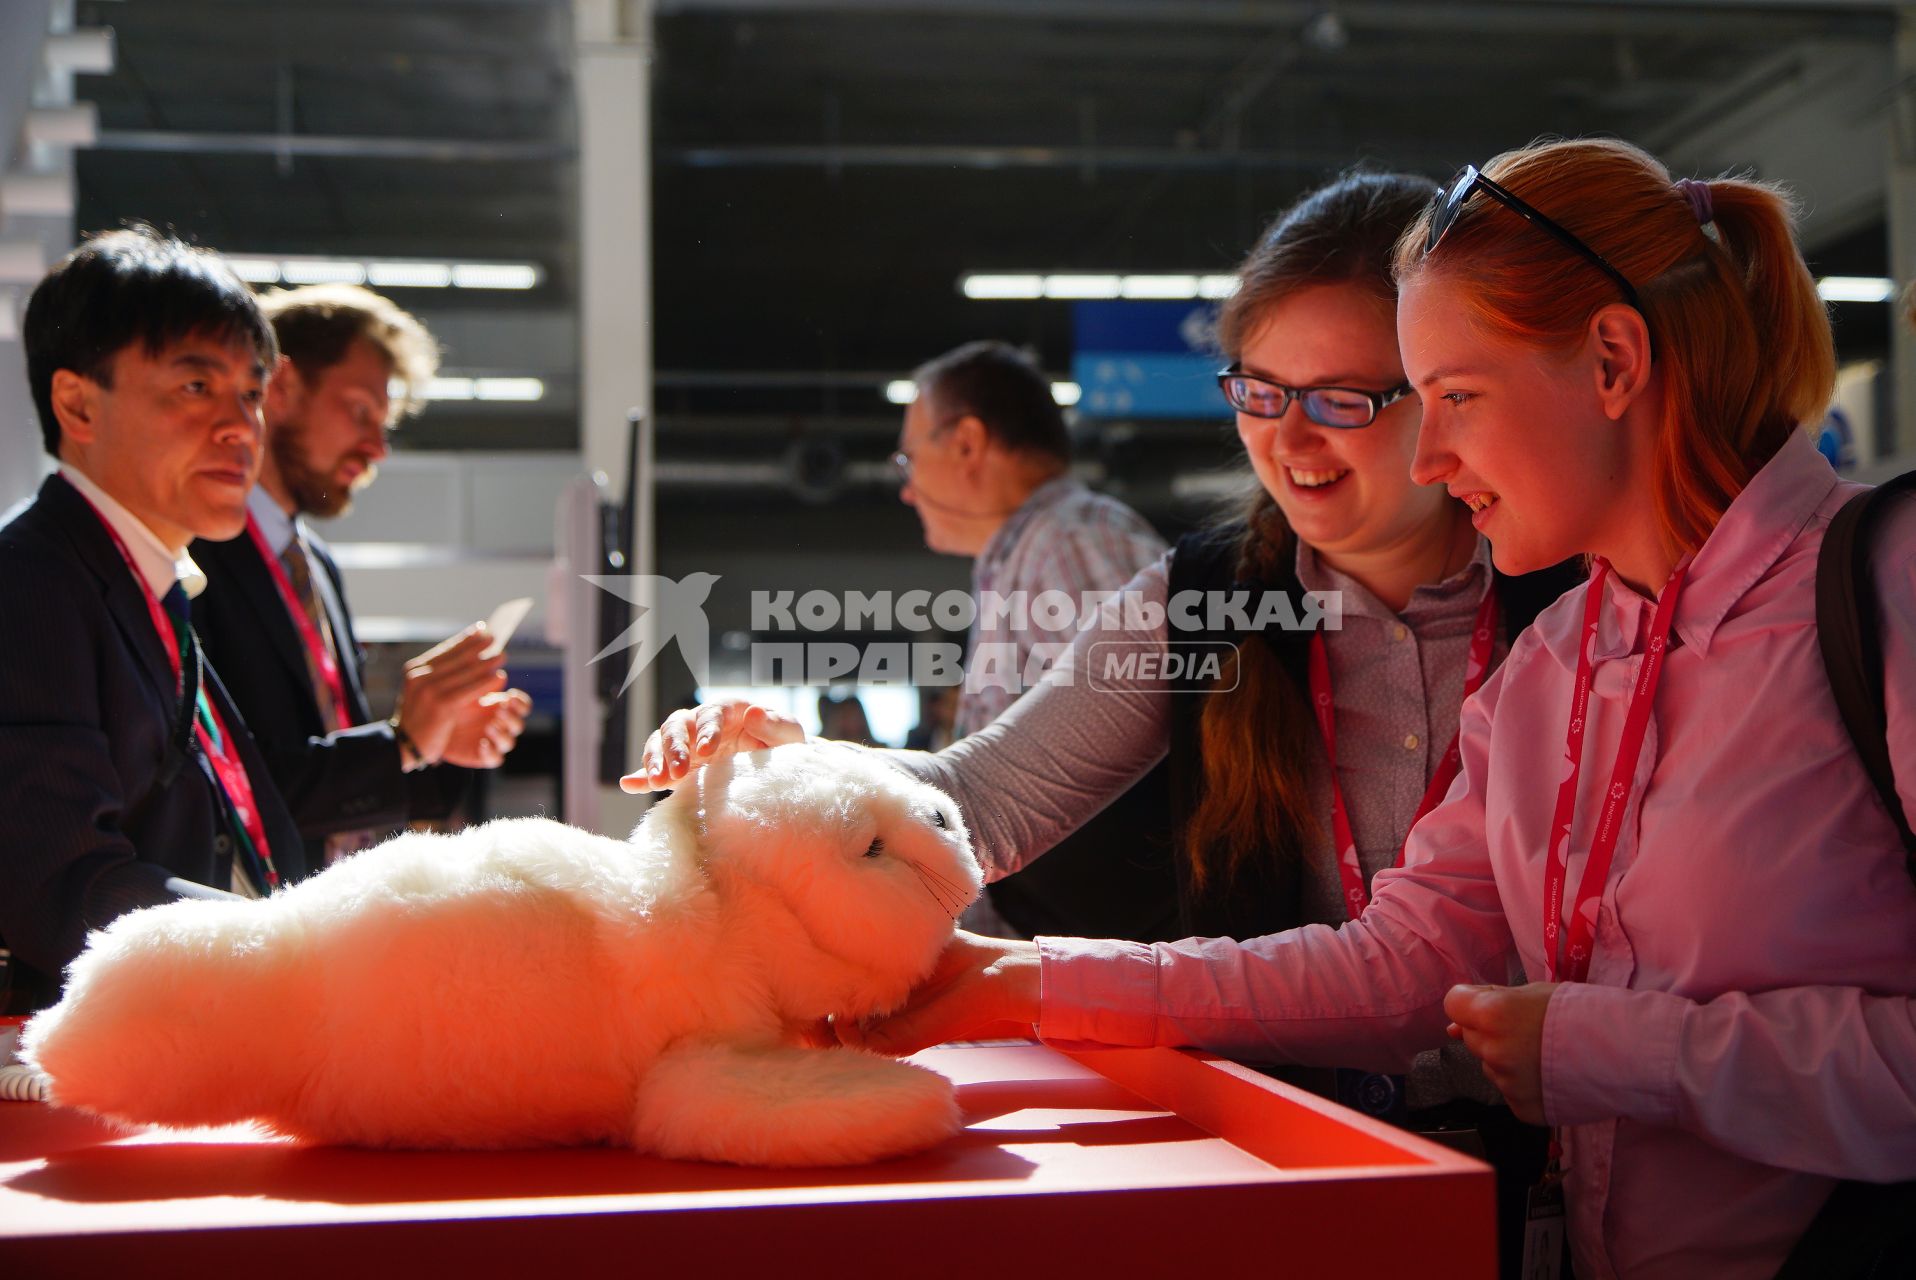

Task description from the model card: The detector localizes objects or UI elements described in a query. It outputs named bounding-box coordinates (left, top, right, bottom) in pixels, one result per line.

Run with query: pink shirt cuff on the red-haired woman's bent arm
left=1542, top=983, right=1690, bottom=1125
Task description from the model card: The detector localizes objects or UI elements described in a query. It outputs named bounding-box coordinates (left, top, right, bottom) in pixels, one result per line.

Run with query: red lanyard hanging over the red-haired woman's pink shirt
left=1544, top=560, right=1690, bottom=983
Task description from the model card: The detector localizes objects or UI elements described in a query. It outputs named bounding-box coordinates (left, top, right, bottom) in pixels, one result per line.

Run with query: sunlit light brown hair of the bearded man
left=259, top=284, right=439, bottom=420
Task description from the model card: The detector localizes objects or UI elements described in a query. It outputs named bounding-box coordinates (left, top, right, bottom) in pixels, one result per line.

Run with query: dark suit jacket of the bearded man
left=194, top=509, right=468, bottom=866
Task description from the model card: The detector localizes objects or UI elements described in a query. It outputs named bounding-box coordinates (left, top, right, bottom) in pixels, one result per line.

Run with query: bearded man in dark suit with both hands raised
left=194, top=286, right=531, bottom=864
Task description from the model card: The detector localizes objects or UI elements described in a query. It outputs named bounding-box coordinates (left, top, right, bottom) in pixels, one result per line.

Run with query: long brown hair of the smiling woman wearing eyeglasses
left=1180, top=172, right=1437, bottom=891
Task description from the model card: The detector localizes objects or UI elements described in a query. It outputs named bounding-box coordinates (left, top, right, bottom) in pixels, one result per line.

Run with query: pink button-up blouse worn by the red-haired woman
left=1038, top=435, right=1916, bottom=1280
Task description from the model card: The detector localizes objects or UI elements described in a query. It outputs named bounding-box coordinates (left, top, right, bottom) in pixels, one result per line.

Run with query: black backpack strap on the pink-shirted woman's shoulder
left=1816, top=471, right=1916, bottom=880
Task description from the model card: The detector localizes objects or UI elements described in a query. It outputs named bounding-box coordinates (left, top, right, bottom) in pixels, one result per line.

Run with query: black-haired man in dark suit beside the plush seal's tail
left=0, top=228, right=307, bottom=1012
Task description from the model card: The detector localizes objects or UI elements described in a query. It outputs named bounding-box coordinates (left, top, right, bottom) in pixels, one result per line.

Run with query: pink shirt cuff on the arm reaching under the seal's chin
left=1037, top=937, right=1157, bottom=1046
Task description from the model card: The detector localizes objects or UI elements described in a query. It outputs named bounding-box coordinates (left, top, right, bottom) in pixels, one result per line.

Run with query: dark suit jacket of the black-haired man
left=0, top=475, right=308, bottom=1010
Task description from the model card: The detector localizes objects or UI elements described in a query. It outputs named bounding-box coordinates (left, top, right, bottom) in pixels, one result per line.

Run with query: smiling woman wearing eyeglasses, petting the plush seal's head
left=627, top=174, right=1581, bottom=1272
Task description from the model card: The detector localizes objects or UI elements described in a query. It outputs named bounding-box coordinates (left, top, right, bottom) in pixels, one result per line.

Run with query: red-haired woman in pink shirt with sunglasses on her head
left=770, top=142, right=1916, bottom=1278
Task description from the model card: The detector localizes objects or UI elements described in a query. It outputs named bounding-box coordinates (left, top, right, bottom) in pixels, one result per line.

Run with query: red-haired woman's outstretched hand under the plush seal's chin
left=832, top=929, right=1038, bottom=1054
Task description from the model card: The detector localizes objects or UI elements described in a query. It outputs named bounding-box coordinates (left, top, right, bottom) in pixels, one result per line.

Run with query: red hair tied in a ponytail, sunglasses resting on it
left=1397, top=140, right=1836, bottom=554
